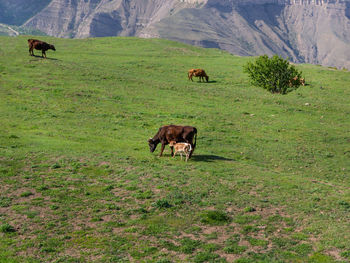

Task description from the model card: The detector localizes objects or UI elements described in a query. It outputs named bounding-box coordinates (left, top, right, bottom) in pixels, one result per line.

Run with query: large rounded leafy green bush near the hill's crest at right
left=244, top=55, right=302, bottom=94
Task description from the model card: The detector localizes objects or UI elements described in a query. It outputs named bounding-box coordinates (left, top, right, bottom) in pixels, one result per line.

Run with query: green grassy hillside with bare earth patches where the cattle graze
left=0, top=37, right=350, bottom=263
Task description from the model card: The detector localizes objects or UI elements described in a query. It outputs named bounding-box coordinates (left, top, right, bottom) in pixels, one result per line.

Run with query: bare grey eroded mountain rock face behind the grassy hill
left=0, top=0, right=350, bottom=69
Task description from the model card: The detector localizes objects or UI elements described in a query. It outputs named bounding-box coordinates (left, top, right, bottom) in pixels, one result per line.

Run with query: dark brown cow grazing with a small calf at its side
left=148, top=125, right=197, bottom=158
